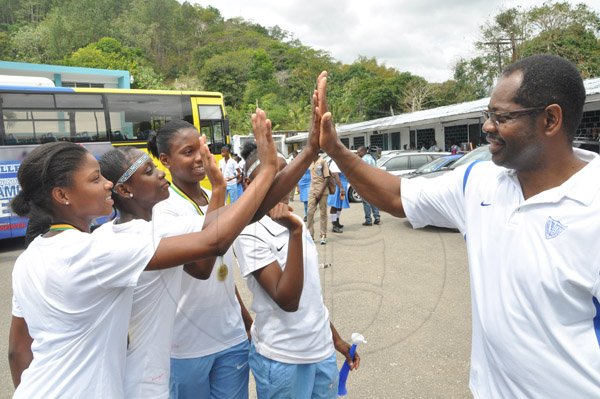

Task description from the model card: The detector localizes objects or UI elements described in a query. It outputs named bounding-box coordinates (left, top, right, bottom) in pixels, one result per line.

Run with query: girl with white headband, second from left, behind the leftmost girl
left=100, top=145, right=225, bottom=399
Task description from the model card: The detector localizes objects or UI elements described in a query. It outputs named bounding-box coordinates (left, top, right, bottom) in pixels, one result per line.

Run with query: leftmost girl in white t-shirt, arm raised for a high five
left=9, top=110, right=276, bottom=398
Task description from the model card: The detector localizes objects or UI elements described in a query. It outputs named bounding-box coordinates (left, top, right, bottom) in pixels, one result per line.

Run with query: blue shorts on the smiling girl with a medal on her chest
left=169, top=340, right=250, bottom=399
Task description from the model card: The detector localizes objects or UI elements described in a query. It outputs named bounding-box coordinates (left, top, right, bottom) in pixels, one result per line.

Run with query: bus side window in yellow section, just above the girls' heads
left=106, top=94, right=191, bottom=141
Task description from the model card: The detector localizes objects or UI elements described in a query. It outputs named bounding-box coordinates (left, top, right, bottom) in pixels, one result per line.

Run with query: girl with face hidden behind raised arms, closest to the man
left=233, top=148, right=360, bottom=399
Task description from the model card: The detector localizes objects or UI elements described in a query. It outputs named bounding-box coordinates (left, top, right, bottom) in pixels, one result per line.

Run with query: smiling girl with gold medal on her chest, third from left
left=148, top=121, right=252, bottom=399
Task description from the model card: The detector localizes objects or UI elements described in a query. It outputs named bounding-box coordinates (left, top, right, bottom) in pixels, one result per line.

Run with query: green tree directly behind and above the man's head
left=454, top=1, right=600, bottom=98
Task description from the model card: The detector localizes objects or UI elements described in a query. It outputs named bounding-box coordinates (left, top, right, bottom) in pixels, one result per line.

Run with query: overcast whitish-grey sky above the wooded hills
left=188, top=0, right=600, bottom=82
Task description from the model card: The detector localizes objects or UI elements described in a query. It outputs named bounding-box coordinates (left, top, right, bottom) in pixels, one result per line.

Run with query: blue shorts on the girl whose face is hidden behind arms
left=249, top=345, right=338, bottom=399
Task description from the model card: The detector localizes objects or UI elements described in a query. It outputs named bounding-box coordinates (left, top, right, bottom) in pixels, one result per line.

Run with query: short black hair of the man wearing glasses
left=502, top=54, right=585, bottom=141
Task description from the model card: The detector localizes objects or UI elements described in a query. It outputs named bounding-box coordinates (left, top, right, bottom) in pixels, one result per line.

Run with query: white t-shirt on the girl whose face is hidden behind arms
left=233, top=216, right=334, bottom=364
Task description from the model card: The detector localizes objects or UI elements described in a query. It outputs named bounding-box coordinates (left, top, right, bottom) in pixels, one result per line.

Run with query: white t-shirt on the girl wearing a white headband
left=123, top=217, right=202, bottom=399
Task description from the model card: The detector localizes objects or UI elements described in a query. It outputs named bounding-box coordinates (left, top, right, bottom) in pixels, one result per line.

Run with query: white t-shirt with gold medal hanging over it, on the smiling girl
left=152, top=189, right=248, bottom=359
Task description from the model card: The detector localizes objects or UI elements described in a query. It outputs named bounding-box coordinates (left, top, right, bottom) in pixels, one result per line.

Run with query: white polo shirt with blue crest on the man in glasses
left=401, top=150, right=600, bottom=398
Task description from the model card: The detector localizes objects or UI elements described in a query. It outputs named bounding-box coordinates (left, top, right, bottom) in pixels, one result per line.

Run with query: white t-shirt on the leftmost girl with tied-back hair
left=13, top=222, right=158, bottom=399
